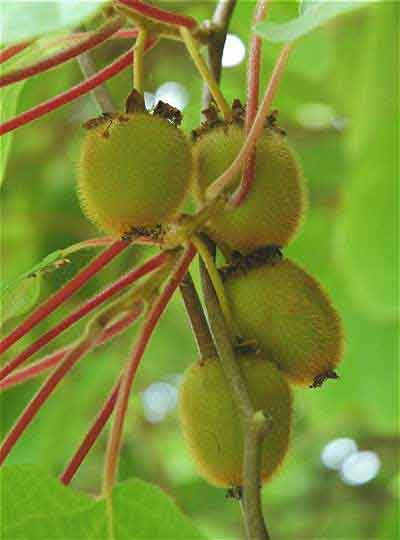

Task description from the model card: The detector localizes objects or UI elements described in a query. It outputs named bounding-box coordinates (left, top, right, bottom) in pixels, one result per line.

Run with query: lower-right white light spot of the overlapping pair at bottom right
left=340, top=451, right=381, bottom=486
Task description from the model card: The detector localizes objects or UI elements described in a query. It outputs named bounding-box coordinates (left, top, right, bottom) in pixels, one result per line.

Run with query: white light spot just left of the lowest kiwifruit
left=142, top=382, right=178, bottom=424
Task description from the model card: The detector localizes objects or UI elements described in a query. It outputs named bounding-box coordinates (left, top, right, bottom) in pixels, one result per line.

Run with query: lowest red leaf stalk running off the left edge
left=0, top=338, right=93, bottom=465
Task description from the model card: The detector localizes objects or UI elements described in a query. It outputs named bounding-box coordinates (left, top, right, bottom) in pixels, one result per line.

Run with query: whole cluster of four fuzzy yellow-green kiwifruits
left=79, top=97, right=343, bottom=487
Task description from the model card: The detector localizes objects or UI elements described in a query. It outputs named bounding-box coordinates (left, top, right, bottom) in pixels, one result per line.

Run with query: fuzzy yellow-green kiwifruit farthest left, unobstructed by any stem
left=78, top=113, right=192, bottom=235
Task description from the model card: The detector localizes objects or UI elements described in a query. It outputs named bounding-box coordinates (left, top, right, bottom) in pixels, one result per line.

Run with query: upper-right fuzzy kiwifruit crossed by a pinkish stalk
left=193, top=124, right=305, bottom=254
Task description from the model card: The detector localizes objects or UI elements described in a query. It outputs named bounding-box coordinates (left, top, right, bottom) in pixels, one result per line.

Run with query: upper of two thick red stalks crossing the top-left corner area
left=0, top=16, right=124, bottom=88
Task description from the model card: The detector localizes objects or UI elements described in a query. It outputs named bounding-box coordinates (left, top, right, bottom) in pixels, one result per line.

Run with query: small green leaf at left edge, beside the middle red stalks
left=0, top=249, right=68, bottom=326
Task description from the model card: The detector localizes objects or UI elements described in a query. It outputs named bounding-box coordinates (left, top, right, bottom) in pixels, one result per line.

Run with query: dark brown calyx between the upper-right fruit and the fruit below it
left=220, top=245, right=283, bottom=279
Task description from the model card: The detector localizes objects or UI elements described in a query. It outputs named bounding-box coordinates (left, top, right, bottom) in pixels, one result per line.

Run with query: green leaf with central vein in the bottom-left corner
left=0, top=465, right=204, bottom=540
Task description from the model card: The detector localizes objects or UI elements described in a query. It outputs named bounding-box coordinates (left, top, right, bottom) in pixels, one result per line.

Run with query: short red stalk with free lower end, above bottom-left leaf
left=60, top=380, right=121, bottom=485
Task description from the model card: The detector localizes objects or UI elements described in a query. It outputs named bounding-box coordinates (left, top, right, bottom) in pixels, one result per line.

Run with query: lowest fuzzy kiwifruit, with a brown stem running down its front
left=179, top=355, right=292, bottom=487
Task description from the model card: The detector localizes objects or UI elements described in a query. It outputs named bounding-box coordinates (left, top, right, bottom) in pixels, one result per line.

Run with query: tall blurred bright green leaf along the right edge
left=338, top=3, right=399, bottom=319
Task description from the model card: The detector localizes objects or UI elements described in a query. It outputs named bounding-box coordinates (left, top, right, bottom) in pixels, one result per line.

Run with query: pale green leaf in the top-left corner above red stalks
left=0, top=0, right=104, bottom=45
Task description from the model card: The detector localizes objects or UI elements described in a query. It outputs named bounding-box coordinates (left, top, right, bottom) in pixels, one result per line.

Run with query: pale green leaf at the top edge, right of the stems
left=255, top=0, right=369, bottom=43
